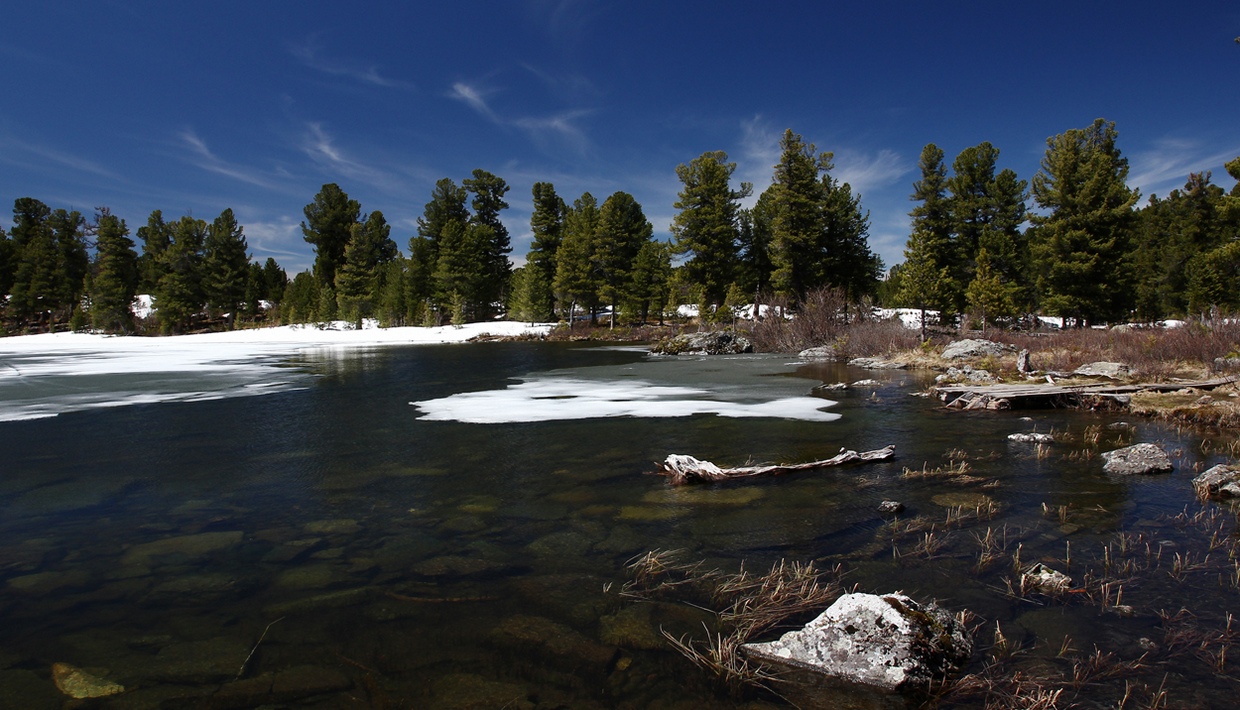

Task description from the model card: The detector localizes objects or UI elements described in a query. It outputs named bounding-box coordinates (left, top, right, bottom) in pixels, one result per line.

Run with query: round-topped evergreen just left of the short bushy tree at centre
left=591, top=192, right=655, bottom=328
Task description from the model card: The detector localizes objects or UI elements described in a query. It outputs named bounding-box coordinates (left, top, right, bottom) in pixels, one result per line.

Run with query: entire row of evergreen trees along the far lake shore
left=0, top=119, right=1240, bottom=333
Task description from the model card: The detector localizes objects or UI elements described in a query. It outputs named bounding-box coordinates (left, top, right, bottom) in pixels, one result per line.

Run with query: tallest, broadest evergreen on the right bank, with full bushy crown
left=1030, top=119, right=1138, bottom=325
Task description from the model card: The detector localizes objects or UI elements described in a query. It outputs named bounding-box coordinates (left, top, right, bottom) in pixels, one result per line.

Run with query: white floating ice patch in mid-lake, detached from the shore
left=409, top=378, right=839, bottom=424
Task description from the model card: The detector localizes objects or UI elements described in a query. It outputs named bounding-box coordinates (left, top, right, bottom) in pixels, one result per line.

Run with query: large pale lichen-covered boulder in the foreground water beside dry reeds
left=742, top=592, right=973, bottom=693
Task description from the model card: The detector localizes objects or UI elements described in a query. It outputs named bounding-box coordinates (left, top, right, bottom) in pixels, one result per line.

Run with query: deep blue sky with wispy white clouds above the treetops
left=0, top=0, right=1240, bottom=273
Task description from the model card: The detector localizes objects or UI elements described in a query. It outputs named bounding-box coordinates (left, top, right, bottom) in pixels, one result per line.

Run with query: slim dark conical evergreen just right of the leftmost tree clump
left=89, top=209, right=138, bottom=333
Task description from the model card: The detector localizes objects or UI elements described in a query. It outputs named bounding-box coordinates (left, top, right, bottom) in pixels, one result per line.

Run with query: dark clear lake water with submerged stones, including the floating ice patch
left=0, top=343, right=1240, bottom=708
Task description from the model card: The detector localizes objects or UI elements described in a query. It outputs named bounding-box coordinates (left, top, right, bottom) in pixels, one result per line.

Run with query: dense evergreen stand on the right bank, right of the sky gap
left=883, top=119, right=1240, bottom=326
